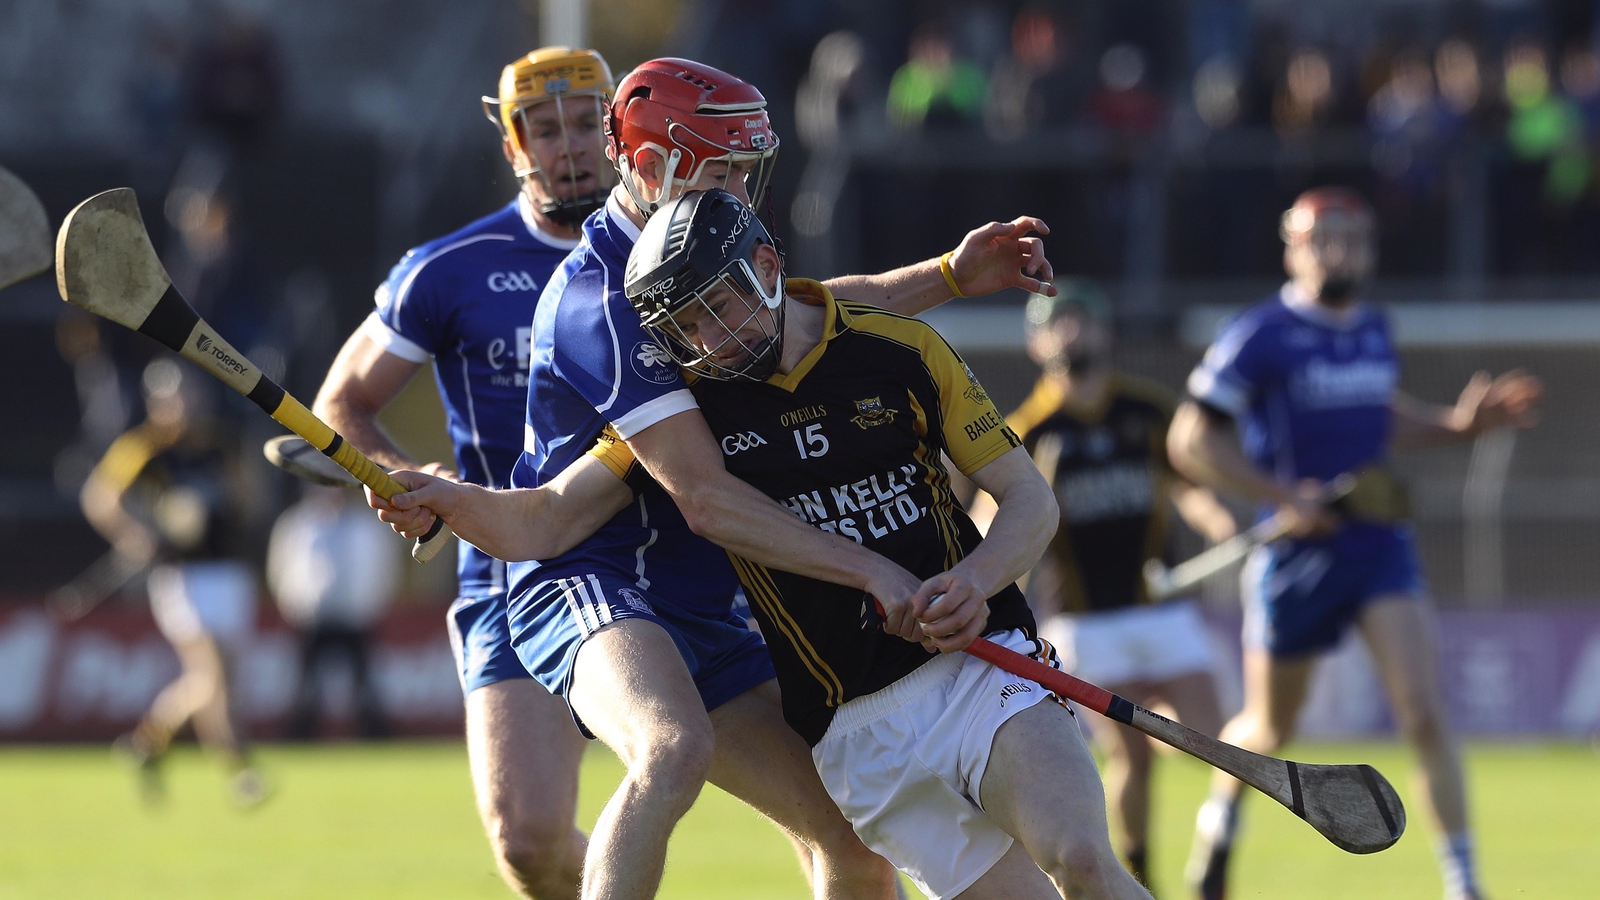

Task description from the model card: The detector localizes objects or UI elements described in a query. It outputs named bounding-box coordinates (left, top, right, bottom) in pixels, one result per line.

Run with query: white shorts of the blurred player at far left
left=149, top=559, right=256, bottom=644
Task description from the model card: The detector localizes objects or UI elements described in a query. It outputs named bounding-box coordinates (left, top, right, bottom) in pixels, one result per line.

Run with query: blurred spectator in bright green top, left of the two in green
left=888, top=24, right=986, bottom=131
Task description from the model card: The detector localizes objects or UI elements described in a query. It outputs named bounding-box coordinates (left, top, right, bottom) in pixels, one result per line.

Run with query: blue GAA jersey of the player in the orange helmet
left=362, top=192, right=578, bottom=597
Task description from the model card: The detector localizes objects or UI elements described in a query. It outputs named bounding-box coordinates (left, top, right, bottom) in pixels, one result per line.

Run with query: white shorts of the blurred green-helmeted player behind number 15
left=1038, top=601, right=1213, bottom=687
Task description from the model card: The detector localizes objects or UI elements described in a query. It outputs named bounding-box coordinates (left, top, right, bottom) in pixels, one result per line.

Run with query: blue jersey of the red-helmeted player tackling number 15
left=510, top=197, right=738, bottom=621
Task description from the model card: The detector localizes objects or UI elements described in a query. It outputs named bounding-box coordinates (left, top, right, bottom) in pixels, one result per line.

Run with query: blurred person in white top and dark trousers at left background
left=267, top=485, right=400, bottom=740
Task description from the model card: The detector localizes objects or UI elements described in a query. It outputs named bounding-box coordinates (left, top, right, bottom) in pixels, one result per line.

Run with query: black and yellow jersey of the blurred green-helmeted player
left=1006, top=375, right=1178, bottom=612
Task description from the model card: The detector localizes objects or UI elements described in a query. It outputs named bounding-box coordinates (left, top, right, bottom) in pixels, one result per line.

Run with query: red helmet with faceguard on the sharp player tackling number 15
left=606, top=59, right=778, bottom=218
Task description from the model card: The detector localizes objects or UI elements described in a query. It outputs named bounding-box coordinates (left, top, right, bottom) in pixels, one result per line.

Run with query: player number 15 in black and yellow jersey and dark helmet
left=371, top=191, right=1149, bottom=900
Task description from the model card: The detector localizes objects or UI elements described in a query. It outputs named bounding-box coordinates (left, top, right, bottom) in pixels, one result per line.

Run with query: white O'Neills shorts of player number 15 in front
left=811, top=631, right=1059, bottom=900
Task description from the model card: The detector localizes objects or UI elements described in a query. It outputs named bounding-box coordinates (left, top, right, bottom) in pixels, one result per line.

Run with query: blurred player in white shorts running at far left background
left=82, top=359, right=266, bottom=807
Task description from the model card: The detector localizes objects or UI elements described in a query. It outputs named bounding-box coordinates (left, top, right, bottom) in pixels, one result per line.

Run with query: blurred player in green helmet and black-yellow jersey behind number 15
left=1006, top=280, right=1234, bottom=884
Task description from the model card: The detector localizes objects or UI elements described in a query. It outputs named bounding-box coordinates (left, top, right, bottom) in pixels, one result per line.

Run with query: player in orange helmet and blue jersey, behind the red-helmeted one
left=315, top=46, right=616, bottom=900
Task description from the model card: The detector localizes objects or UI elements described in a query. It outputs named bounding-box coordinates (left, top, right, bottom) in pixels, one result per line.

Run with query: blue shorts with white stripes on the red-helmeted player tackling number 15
left=512, top=573, right=778, bottom=711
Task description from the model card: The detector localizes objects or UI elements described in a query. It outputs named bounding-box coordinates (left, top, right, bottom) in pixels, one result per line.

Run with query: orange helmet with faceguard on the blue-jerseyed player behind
left=483, top=46, right=616, bottom=226
